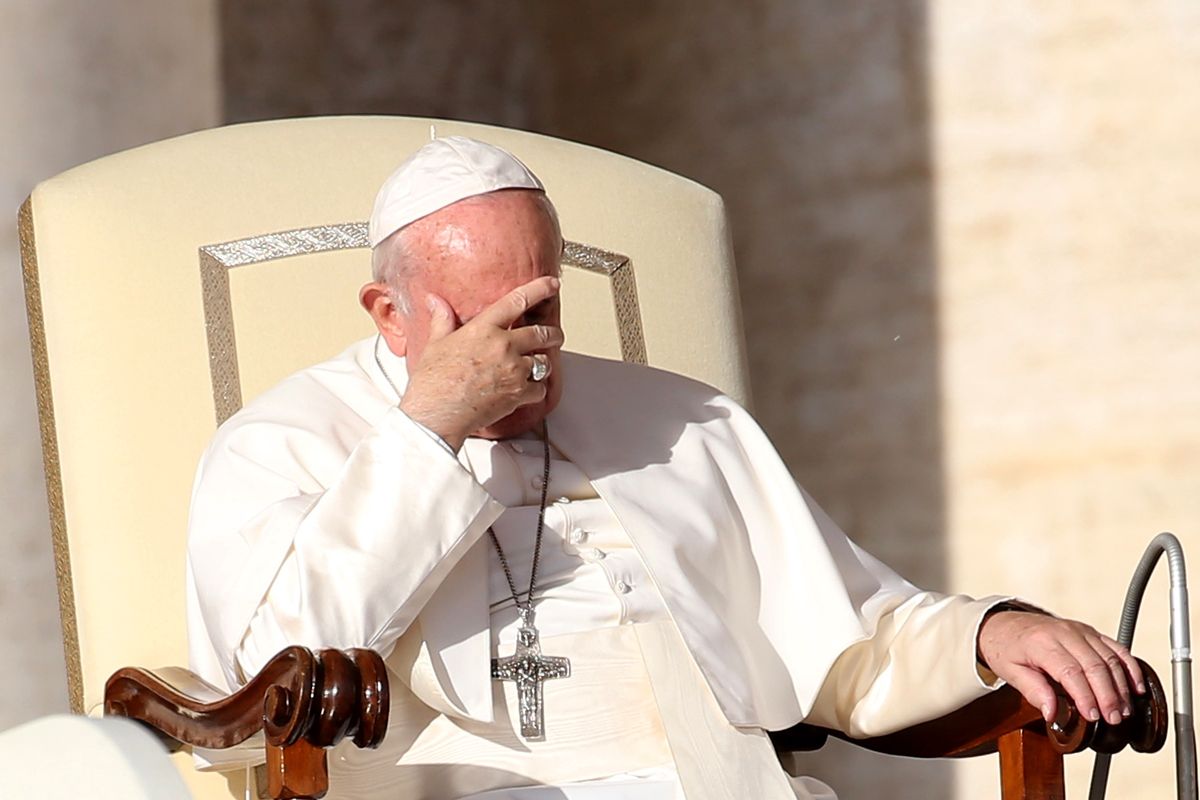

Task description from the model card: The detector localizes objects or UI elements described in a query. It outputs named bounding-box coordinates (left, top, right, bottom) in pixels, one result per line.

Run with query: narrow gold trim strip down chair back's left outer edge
left=17, top=198, right=84, bottom=714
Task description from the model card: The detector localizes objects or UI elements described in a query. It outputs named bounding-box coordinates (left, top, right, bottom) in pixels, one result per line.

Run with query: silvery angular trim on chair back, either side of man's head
left=199, top=222, right=646, bottom=425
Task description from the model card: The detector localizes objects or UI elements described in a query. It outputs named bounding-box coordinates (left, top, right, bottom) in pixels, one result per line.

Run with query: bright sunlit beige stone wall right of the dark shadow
left=929, top=0, right=1200, bottom=800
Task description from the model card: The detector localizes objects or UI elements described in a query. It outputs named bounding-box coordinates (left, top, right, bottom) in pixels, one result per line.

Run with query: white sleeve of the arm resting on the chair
left=805, top=591, right=1008, bottom=738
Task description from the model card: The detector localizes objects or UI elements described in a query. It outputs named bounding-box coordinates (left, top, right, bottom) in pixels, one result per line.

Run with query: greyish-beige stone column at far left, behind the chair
left=0, top=0, right=221, bottom=730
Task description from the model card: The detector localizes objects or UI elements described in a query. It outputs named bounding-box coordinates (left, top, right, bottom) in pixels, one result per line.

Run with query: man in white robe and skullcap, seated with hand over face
left=188, top=138, right=1141, bottom=800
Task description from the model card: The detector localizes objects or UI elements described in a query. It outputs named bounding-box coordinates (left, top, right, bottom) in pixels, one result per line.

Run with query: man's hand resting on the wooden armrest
left=979, top=610, right=1146, bottom=724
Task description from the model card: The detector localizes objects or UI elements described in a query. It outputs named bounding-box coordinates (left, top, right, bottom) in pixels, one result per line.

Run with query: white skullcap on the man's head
left=367, top=136, right=546, bottom=247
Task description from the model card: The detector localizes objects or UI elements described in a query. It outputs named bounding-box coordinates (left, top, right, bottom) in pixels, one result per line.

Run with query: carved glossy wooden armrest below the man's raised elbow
left=104, top=646, right=389, bottom=798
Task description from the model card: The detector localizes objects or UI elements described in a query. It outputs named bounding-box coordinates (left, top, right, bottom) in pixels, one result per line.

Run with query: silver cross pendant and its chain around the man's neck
left=374, top=337, right=571, bottom=741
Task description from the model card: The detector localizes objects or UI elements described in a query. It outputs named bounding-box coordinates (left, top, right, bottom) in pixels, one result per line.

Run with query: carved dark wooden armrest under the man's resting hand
left=770, top=658, right=1168, bottom=800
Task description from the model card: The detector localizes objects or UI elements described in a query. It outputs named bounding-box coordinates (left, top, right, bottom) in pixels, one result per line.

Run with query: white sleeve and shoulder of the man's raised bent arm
left=188, top=408, right=504, bottom=686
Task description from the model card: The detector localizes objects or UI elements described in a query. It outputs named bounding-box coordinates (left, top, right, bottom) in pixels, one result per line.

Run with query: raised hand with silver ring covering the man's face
left=400, top=276, right=563, bottom=451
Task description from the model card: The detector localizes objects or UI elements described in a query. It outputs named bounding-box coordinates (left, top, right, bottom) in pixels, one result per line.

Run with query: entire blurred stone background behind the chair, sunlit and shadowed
left=0, top=0, right=1200, bottom=800
